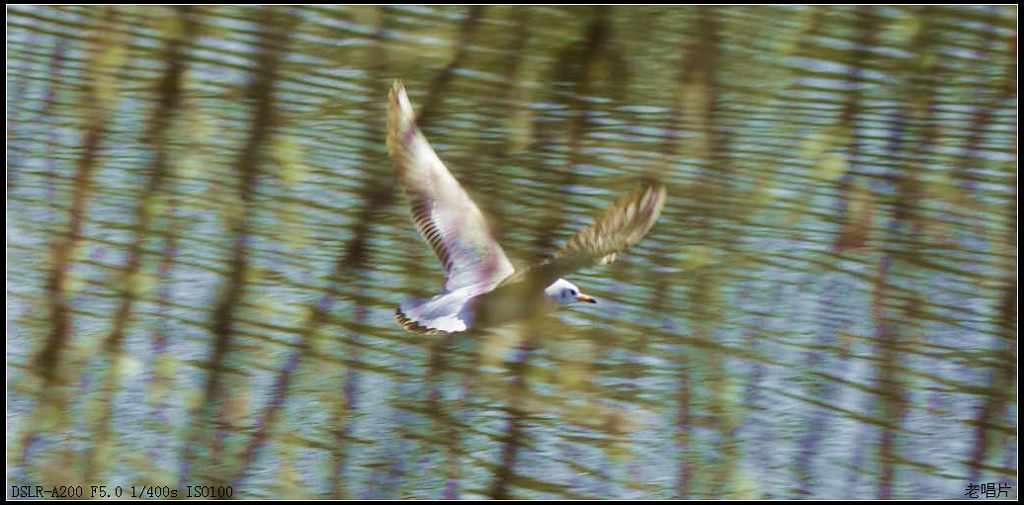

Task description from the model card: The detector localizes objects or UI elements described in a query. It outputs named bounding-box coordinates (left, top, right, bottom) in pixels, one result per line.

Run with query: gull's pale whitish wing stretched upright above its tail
left=387, top=81, right=515, bottom=292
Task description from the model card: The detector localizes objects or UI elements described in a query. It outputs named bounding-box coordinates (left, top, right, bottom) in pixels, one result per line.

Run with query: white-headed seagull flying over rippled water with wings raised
left=387, top=80, right=666, bottom=335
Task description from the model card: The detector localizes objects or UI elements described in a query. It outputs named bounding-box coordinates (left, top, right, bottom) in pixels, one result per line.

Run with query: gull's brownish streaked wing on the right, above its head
left=506, top=180, right=666, bottom=288
